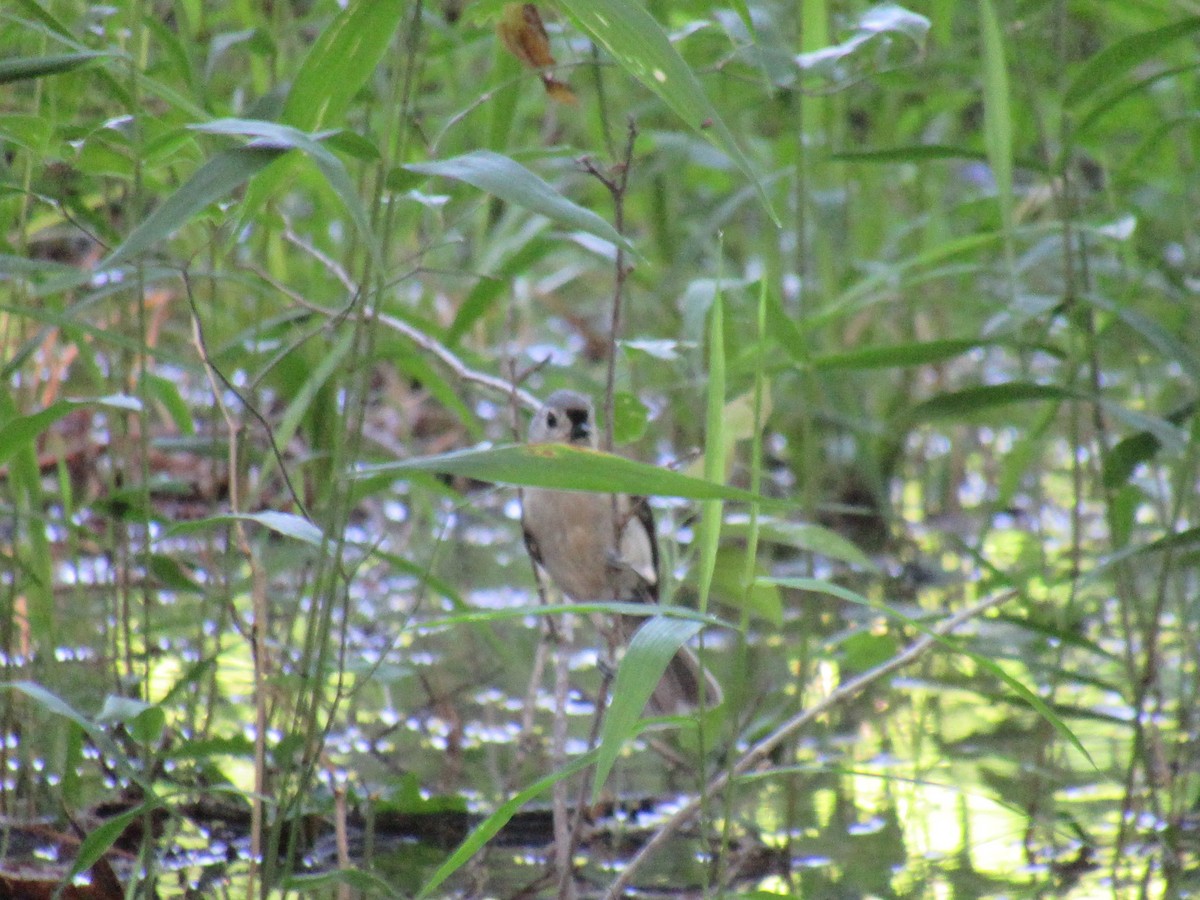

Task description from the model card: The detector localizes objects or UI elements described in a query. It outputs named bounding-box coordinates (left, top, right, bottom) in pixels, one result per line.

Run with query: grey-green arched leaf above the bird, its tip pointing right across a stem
left=404, top=150, right=632, bottom=250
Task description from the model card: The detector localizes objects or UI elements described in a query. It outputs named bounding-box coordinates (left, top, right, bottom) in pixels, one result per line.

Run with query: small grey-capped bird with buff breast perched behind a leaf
left=523, top=390, right=721, bottom=714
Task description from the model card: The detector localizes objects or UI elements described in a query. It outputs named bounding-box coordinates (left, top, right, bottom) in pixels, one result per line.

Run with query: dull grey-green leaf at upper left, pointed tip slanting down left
left=97, top=146, right=287, bottom=269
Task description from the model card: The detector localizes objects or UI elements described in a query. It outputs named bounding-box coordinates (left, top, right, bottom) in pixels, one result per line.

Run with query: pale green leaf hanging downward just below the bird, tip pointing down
left=592, top=616, right=701, bottom=802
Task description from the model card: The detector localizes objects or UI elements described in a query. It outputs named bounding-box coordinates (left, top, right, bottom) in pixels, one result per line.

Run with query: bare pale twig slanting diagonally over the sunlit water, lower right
left=605, top=590, right=1018, bottom=900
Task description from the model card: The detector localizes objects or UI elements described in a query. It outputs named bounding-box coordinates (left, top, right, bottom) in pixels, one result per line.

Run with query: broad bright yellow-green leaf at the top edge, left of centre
left=282, top=1, right=408, bottom=131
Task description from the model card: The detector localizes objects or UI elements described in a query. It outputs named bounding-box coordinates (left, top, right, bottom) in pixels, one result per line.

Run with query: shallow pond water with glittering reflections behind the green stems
left=5, top=434, right=1200, bottom=898
